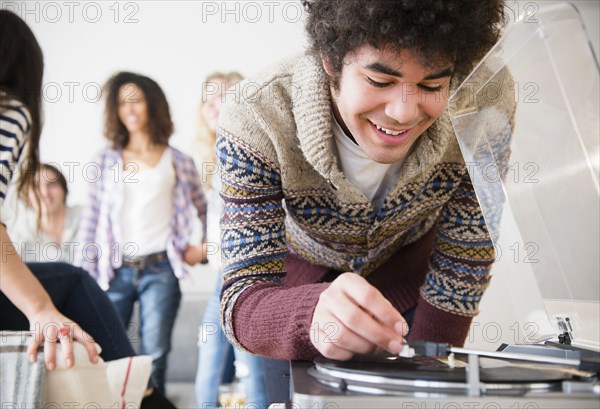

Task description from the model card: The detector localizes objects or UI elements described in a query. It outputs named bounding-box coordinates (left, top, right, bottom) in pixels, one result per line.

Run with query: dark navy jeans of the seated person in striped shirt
left=0, top=263, right=135, bottom=361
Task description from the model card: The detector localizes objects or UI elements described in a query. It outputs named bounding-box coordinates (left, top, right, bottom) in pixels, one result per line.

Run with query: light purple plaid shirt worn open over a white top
left=75, top=147, right=207, bottom=289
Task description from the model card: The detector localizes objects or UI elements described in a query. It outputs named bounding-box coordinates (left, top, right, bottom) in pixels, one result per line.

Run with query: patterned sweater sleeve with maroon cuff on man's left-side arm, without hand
left=217, top=130, right=322, bottom=359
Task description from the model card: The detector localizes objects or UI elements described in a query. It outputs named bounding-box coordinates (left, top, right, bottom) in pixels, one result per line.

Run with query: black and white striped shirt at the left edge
left=0, top=94, right=31, bottom=224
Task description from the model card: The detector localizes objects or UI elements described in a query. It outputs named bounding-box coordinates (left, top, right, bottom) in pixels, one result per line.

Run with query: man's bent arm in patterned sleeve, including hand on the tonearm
left=217, top=131, right=406, bottom=359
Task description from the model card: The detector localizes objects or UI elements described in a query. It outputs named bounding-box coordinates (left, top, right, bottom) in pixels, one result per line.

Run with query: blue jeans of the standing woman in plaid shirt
left=107, top=260, right=181, bottom=395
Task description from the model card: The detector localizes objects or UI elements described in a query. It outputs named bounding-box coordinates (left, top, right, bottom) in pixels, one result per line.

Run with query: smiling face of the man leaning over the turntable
left=323, top=46, right=453, bottom=163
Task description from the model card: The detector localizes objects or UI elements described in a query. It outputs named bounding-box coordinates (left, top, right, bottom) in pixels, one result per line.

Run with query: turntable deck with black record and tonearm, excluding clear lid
left=292, top=343, right=600, bottom=409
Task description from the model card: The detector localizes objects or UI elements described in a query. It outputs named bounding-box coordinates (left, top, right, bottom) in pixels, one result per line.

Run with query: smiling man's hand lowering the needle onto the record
left=310, top=273, right=408, bottom=360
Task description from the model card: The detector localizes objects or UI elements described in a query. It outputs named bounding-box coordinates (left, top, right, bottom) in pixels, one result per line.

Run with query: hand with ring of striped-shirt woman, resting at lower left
left=27, top=307, right=99, bottom=371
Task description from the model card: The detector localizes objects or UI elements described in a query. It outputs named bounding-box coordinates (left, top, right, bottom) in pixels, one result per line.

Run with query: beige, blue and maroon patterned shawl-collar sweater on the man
left=217, top=55, right=511, bottom=359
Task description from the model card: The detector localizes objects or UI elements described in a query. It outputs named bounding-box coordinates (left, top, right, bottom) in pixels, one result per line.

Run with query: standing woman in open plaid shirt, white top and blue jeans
left=77, top=72, right=206, bottom=394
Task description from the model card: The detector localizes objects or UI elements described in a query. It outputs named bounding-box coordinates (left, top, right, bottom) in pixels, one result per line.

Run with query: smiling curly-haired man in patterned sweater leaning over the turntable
left=217, top=0, right=514, bottom=400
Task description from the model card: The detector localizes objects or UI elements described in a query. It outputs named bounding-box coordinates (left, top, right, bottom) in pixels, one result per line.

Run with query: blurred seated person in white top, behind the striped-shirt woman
left=8, top=163, right=82, bottom=264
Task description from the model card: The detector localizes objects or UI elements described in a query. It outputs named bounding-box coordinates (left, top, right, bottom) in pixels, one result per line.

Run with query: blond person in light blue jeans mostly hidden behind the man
left=192, top=72, right=268, bottom=408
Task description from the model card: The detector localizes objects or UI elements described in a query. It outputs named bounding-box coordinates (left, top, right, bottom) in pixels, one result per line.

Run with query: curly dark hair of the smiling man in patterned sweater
left=302, top=0, right=505, bottom=82
